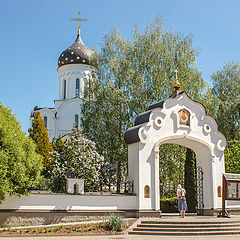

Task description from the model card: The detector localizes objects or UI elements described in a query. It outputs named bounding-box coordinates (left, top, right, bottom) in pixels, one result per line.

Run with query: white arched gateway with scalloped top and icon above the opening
left=125, top=92, right=226, bottom=215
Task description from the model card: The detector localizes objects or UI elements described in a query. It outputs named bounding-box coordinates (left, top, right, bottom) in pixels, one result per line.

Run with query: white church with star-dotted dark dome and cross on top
left=30, top=13, right=93, bottom=141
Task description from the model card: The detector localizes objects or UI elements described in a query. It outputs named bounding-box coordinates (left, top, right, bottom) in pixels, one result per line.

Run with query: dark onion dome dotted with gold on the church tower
left=58, top=31, right=93, bottom=67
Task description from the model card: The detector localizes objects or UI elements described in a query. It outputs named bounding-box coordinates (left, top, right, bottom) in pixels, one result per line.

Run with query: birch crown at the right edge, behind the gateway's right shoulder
left=212, top=62, right=240, bottom=140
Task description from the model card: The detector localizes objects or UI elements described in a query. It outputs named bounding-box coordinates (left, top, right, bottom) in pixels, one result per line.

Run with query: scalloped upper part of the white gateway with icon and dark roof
left=124, top=91, right=226, bottom=155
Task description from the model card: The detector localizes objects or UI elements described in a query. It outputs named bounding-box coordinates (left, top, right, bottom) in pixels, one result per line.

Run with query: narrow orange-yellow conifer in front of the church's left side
left=29, top=112, right=52, bottom=167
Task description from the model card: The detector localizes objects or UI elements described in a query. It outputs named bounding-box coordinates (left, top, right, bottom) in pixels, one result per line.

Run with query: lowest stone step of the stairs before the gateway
left=128, top=230, right=240, bottom=236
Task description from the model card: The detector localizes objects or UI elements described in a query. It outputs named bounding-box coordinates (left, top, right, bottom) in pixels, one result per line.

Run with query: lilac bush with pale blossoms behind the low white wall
left=48, top=131, right=114, bottom=190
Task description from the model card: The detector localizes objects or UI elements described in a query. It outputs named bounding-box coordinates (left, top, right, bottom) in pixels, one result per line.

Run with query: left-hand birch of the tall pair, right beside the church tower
left=81, top=29, right=130, bottom=184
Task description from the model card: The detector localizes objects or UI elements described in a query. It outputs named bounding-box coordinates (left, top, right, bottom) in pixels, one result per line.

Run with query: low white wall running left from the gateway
left=0, top=194, right=137, bottom=210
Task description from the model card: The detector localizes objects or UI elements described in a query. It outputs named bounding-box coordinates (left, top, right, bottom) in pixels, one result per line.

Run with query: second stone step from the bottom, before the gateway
left=133, top=227, right=240, bottom=232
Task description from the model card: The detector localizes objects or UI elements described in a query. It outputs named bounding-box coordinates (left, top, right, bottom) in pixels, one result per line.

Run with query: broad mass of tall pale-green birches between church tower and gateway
left=82, top=17, right=206, bottom=184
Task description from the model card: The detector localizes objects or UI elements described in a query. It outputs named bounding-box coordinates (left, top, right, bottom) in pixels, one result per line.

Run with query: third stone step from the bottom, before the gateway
left=137, top=223, right=240, bottom=228
